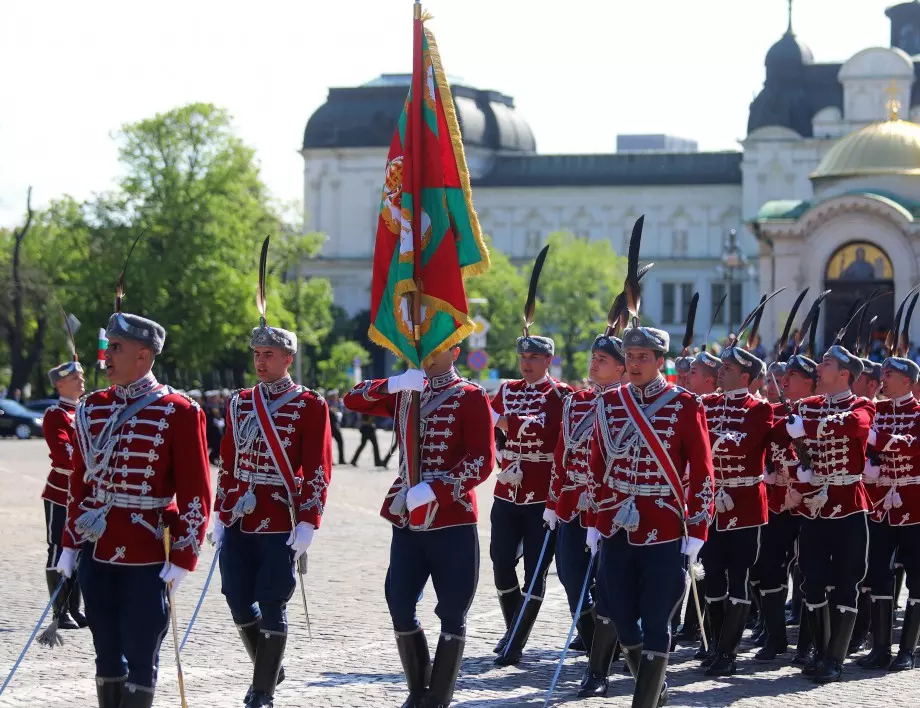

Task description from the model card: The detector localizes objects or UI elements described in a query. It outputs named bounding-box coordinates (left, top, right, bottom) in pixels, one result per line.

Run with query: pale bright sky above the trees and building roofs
left=0, top=0, right=894, bottom=226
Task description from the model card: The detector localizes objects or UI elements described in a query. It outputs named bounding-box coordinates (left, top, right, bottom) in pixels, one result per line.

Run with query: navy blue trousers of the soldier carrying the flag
left=385, top=524, right=479, bottom=637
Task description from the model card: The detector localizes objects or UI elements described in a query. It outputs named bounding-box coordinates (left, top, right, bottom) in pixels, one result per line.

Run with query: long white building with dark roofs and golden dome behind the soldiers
left=303, top=2, right=920, bottom=360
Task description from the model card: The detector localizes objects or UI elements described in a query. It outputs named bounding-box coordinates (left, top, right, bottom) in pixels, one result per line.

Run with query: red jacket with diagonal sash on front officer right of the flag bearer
left=591, top=377, right=714, bottom=545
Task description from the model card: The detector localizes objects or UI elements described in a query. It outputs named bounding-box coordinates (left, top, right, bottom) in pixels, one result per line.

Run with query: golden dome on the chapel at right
left=809, top=120, right=920, bottom=179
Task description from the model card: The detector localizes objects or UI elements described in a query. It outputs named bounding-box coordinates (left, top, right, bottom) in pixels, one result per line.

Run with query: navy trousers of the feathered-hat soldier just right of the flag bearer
left=489, top=499, right=556, bottom=600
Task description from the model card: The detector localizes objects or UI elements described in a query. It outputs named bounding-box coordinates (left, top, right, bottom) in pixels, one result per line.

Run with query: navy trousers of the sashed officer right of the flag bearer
left=598, top=531, right=687, bottom=654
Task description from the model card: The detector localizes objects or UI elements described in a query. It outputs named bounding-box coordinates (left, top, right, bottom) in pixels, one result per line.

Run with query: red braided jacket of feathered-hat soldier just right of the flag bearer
left=492, top=376, right=572, bottom=504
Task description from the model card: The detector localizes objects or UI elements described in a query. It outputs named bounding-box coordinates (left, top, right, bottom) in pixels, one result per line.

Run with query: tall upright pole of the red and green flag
left=406, top=0, right=425, bottom=486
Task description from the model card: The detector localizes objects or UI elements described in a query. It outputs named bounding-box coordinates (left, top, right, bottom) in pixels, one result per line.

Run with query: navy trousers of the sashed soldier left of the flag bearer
left=220, top=526, right=297, bottom=634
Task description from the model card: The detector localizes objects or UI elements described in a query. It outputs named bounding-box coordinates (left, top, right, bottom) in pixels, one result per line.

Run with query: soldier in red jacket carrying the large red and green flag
left=345, top=346, right=495, bottom=708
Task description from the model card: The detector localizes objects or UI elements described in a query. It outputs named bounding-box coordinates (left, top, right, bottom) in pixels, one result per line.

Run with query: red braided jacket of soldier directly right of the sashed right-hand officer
left=702, top=388, right=773, bottom=531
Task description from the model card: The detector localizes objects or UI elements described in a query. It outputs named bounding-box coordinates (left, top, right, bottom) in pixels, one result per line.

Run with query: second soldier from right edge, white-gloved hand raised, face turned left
left=786, top=344, right=875, bottom=683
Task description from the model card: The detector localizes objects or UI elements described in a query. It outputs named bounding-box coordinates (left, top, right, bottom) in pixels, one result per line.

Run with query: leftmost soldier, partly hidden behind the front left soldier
left=42, top=359, right=86, bottom=629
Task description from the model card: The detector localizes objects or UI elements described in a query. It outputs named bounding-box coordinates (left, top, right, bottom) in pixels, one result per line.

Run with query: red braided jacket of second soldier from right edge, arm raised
left=793, top=391, right=875, bottom=519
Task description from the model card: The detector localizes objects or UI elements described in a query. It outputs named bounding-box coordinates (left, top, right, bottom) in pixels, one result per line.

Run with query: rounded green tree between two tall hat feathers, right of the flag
left=534, top=231, right=626, bottom=379
